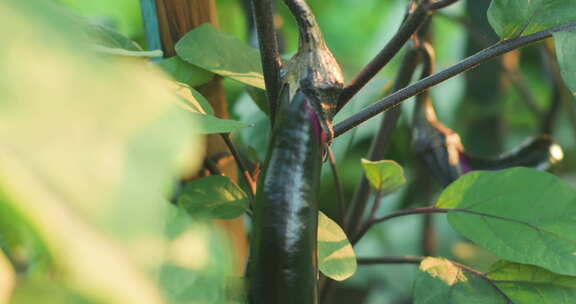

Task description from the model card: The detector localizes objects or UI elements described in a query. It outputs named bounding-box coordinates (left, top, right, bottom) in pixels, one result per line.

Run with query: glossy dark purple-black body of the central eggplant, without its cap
left=248, top=90, right=322, bottom=304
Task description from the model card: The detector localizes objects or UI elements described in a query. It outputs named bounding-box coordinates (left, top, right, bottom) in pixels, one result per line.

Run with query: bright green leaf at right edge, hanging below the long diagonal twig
left=554, top=28, right=576, bottom=96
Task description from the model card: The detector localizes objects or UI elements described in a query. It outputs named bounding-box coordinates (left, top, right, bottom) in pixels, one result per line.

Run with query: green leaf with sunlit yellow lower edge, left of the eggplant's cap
left=176, top=23, right=264, bottom=89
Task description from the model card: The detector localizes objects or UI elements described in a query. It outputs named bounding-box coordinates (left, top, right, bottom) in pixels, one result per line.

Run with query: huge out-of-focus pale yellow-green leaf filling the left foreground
left=0, top=0, right=203, bottom=303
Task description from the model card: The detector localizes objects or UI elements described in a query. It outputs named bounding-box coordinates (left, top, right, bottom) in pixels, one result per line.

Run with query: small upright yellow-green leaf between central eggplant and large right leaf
left=362, top=159, right=406, bottom=194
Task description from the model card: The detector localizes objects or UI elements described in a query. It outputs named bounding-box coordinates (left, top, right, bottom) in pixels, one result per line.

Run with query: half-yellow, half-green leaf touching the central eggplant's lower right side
left=318, top=212, right=357, bottom=281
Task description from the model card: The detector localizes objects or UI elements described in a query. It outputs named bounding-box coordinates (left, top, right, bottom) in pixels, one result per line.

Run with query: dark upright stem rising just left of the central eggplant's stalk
left=252, top=0, right=281, bottom=122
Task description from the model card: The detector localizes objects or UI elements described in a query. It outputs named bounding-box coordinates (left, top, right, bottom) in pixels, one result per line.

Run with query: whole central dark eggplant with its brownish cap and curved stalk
left=248, top=0, right=343, bottom=304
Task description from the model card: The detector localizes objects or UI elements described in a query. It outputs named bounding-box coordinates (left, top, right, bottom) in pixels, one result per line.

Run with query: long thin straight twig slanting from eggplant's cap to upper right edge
left=334, top=22, right=576, bottom=137
